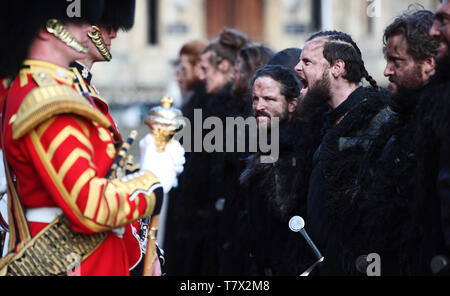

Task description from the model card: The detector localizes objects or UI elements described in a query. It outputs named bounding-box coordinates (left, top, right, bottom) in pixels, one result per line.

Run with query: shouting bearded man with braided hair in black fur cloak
left=295, top=31, right=395, bottom=275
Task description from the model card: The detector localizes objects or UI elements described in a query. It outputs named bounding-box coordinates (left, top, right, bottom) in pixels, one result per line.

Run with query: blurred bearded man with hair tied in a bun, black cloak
left=165, top=29, right=248, bottom=275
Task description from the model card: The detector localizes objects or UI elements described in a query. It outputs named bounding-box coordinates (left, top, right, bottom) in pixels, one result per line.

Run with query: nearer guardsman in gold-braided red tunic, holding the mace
left=0, top=0, right=184, bottom=275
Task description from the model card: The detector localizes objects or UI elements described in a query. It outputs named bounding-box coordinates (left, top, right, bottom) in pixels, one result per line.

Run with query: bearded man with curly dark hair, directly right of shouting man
left=342, top=10, right=438, bottom=275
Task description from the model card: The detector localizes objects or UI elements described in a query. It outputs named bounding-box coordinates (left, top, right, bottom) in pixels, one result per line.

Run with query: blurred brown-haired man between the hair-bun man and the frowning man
left=218, top=44, right=274, bottom=275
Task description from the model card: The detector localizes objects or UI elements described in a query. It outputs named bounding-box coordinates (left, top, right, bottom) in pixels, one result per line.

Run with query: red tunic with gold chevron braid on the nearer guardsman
left=3, top=60, right=163, bottom=275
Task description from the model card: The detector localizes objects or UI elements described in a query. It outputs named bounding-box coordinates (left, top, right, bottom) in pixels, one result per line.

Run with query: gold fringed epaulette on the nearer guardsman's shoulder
left=12, top=74, right=111, bottom=140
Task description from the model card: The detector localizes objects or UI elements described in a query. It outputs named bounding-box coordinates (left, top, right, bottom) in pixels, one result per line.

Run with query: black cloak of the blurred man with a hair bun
left=163, top=83, right=211, bottom=276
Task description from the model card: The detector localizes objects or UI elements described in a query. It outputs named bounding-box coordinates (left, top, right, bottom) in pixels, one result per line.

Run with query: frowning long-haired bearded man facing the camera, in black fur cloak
left=236, top=65, right=318, bottom=276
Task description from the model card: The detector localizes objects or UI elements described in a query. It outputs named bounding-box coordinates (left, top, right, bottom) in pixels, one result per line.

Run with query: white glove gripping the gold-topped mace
left=139, top=133, right=185, bottom=193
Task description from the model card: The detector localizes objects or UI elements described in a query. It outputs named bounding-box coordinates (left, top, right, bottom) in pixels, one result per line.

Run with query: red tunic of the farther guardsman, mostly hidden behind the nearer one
left=71, top=62, right=143, bottom=270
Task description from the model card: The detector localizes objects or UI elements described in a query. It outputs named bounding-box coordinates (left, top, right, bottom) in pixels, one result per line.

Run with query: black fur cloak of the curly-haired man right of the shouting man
left=343, top=89, right=422, bottom=275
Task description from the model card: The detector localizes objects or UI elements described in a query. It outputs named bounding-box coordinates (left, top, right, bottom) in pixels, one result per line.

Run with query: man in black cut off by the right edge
left=411, top=0, right=450, bottom=275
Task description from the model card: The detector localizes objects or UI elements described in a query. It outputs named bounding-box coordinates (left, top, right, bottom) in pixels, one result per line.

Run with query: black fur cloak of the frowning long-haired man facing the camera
left=236, top=112, right=322, bottom=276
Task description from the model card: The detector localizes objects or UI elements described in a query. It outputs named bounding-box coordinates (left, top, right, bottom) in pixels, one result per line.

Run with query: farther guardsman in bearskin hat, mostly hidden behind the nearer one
left=70, top=0, right=146, bottom=275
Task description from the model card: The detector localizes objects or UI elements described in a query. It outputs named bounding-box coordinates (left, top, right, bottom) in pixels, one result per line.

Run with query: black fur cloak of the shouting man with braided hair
left=312, top=87, right=397, bottom=275
